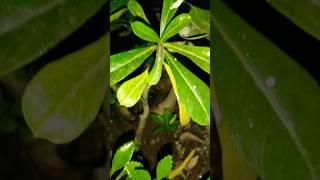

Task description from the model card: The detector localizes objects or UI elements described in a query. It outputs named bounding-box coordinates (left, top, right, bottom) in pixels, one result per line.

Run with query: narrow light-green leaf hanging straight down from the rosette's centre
left=149, top=45, right=164, bottom=86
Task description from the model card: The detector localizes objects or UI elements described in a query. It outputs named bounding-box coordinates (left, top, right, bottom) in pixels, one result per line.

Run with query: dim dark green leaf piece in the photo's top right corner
left=267, top=0, right=320, bottom=40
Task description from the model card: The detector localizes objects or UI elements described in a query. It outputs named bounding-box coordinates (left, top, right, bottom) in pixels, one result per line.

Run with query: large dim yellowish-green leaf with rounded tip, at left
left=22, top=36, right=108, bottom=144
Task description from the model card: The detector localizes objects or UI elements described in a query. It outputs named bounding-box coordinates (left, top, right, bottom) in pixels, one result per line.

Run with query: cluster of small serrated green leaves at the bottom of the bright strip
left=110, top=141, right=173, bottom=180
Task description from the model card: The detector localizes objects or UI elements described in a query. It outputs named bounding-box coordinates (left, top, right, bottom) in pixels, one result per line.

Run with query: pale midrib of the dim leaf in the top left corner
left=0, top=0, right=64, bottom=36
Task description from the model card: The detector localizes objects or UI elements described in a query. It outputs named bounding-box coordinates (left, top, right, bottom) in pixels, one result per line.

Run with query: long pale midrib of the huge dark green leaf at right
left=212, top=17, right=317, bottom=180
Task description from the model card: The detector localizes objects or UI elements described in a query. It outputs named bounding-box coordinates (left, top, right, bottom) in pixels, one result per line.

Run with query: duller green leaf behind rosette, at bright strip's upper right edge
left=189, top=5, right=210, bottom=33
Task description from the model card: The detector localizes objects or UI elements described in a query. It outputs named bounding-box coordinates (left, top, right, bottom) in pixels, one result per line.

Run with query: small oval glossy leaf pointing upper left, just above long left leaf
left=131, top=21, right=160, bottom=42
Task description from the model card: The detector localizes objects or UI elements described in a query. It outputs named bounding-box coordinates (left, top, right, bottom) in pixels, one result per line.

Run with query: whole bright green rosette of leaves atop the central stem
left=110, top=0, right=210, bottom=125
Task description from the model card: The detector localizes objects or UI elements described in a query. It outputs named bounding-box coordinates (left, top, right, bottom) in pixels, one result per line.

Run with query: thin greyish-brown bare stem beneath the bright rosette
left=135, top=86, right=150, bottom=145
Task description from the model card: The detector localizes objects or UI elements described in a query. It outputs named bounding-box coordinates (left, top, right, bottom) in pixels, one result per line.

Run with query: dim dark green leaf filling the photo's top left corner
left=0, top=0, right=105, bottom=76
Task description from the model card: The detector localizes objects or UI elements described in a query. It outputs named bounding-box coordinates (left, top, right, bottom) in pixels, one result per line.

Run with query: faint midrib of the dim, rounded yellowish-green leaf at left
left=38, top=56, right=106, bottom=132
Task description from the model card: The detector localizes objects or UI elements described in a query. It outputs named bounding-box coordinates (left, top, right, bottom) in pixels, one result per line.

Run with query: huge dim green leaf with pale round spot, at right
left=211, top=0, right=320, bottom=180
